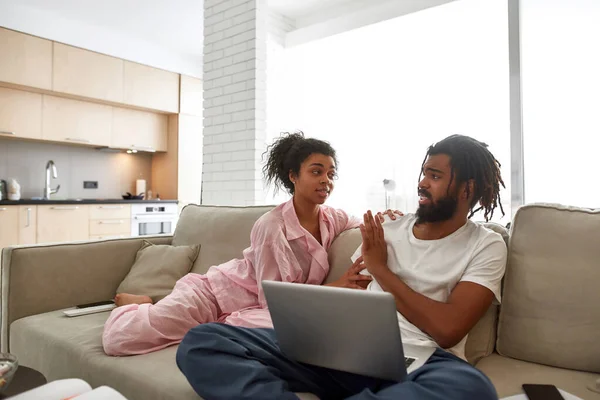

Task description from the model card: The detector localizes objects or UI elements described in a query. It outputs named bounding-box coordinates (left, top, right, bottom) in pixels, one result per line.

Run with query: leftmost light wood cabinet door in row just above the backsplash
left=0, top=86, right=42, bottom=139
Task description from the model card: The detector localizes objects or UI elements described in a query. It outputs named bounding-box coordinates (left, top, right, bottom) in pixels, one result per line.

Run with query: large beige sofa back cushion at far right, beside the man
left=497, top=204, right=600, bottom=372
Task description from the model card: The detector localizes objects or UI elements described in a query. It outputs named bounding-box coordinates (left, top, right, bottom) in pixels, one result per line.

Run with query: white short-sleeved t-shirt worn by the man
left=352, top=214, right=507, bottom=359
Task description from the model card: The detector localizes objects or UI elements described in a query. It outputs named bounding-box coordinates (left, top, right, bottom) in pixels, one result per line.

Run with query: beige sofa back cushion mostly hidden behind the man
left=325, top=223, right=508, bottom=364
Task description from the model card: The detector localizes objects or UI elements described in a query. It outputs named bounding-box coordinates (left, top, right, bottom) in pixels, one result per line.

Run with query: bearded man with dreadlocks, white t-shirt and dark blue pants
left=177, top=135, right=506, bottom=400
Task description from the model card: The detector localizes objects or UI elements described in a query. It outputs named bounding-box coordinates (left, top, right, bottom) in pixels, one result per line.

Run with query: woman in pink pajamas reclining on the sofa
left=102, top=133, right=384, bottom=355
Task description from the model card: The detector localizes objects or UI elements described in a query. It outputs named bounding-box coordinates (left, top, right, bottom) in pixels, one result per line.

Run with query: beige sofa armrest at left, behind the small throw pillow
left=0, top=236, right=172, bottom=351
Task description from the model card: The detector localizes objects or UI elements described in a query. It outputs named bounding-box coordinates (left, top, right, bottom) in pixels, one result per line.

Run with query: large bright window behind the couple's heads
left=268, top=0, right=510, bottom=222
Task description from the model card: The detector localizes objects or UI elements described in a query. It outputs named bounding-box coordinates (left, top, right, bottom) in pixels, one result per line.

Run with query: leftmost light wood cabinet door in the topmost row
left=0, top=28, right=52, bottom=90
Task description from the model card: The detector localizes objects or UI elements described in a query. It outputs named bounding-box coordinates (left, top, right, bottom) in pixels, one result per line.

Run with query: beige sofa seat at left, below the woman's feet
left=10, top=311, right=200, bottom=400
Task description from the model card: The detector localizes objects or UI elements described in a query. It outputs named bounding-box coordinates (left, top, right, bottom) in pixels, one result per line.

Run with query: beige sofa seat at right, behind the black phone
left=477, top=353, right=600, bottom=400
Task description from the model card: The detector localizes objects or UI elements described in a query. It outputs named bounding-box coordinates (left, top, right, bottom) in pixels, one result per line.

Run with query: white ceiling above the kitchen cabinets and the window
left=0, top=0, right=452, bottom=76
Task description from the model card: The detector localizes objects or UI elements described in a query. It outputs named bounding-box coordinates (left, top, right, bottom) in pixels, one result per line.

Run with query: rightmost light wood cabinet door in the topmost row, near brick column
left=123, top=61, right=179, bottom=113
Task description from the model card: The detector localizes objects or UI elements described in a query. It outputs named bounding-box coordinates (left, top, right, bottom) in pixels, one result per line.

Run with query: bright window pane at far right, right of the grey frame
left=521, top=0, right=600, bottom=208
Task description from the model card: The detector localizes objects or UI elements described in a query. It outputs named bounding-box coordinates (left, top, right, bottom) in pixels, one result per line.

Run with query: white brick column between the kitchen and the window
left=202, top=0, right=268, bottom=205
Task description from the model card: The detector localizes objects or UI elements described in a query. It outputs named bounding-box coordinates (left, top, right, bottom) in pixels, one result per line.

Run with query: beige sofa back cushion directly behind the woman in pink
left=172, top=204, right=273, bottom=274
